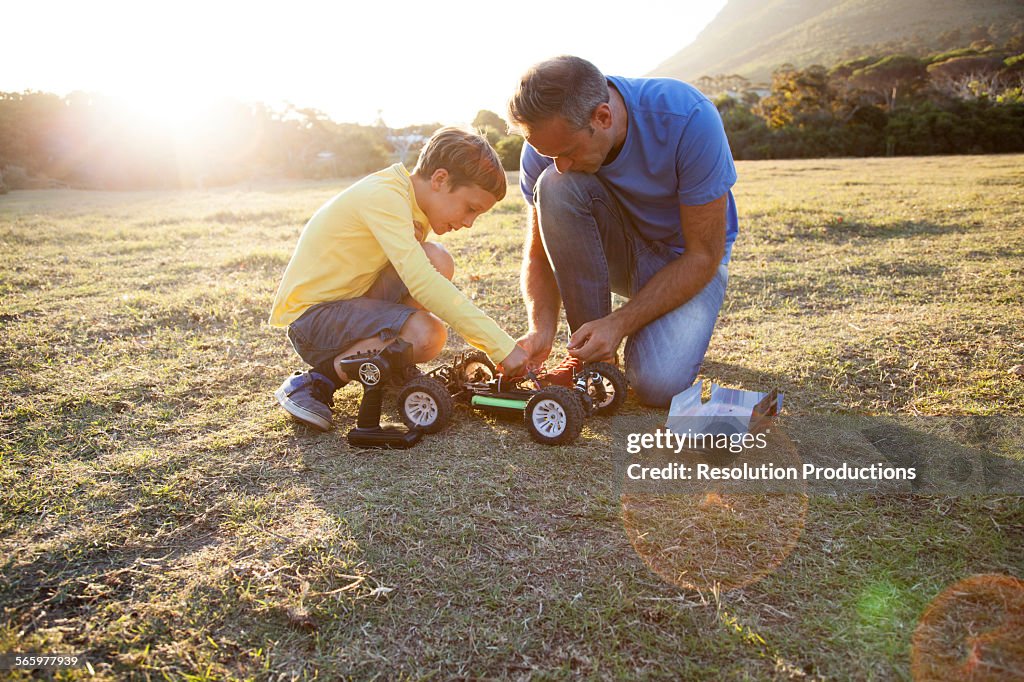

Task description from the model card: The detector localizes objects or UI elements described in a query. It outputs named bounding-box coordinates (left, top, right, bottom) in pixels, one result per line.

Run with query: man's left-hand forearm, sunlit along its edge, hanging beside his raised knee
left=518, top=206, right=562, bottom=367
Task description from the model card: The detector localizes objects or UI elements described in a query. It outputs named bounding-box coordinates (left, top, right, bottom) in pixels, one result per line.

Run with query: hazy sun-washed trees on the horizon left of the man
left=0, top=91, right=521, bottom=191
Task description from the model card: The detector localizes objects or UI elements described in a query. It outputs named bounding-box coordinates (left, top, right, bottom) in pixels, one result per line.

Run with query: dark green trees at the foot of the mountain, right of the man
left=696, top=35, right=1024, bottom=159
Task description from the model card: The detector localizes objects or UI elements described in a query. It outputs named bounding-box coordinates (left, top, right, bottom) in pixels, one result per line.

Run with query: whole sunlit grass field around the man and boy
left=0, top=156, right=1024, bottom=680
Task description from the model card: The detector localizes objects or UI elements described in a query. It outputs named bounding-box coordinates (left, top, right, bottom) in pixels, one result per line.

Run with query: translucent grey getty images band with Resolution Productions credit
left=616, top=416, right=1024, bottom=495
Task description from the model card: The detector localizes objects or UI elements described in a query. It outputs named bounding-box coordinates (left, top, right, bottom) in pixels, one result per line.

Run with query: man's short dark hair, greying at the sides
left=509, top=55, right=608, bottom=133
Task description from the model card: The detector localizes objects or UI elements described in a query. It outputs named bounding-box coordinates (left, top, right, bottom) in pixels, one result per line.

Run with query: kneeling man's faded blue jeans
left=535, top=166, right=729, bottom=407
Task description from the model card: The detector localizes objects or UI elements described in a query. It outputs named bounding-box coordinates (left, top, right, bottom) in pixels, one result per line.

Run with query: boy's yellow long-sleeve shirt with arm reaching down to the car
left=269, top=164, right=515, bottom=363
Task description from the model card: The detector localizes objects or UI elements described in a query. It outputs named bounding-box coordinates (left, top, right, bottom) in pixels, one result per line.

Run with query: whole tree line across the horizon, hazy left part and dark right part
left=0, top=30, right=1024, bottom=191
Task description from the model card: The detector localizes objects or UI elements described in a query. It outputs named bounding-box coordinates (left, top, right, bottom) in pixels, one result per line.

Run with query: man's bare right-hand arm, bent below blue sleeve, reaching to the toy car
left=569, top=195, right=727, bottom=361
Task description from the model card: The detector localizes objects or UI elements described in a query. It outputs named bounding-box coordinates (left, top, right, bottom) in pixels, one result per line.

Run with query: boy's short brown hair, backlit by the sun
left=413, top=127, right=507, bottom=201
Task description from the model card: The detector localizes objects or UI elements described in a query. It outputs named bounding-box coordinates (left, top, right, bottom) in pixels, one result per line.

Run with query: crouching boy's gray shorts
left=288, top=265, right=418, bottom=367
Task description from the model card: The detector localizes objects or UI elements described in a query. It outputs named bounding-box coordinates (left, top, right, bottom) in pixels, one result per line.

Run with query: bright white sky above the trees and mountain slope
left=6, top=0, right=725, bottom=127
